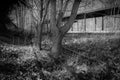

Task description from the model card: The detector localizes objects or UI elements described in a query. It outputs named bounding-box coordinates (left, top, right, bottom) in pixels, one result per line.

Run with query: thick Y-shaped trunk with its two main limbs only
left=50, top=0, right=81, bottom=58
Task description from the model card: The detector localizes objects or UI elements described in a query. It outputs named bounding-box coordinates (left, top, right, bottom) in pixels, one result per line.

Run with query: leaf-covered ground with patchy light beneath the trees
left=0, top=37, right=120, bottom=80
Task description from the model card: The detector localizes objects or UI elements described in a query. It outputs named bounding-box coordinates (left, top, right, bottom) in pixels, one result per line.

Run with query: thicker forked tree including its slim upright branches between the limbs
left=50, top=0, right=81, bottom=58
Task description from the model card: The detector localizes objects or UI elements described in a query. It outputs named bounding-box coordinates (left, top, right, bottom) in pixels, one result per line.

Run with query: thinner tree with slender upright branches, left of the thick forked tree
left=32, top=0, right=50, bottom=50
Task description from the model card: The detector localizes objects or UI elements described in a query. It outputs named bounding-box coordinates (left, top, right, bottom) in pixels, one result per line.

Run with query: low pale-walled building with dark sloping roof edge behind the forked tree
left=63, top=7, right=120, bottom=33
